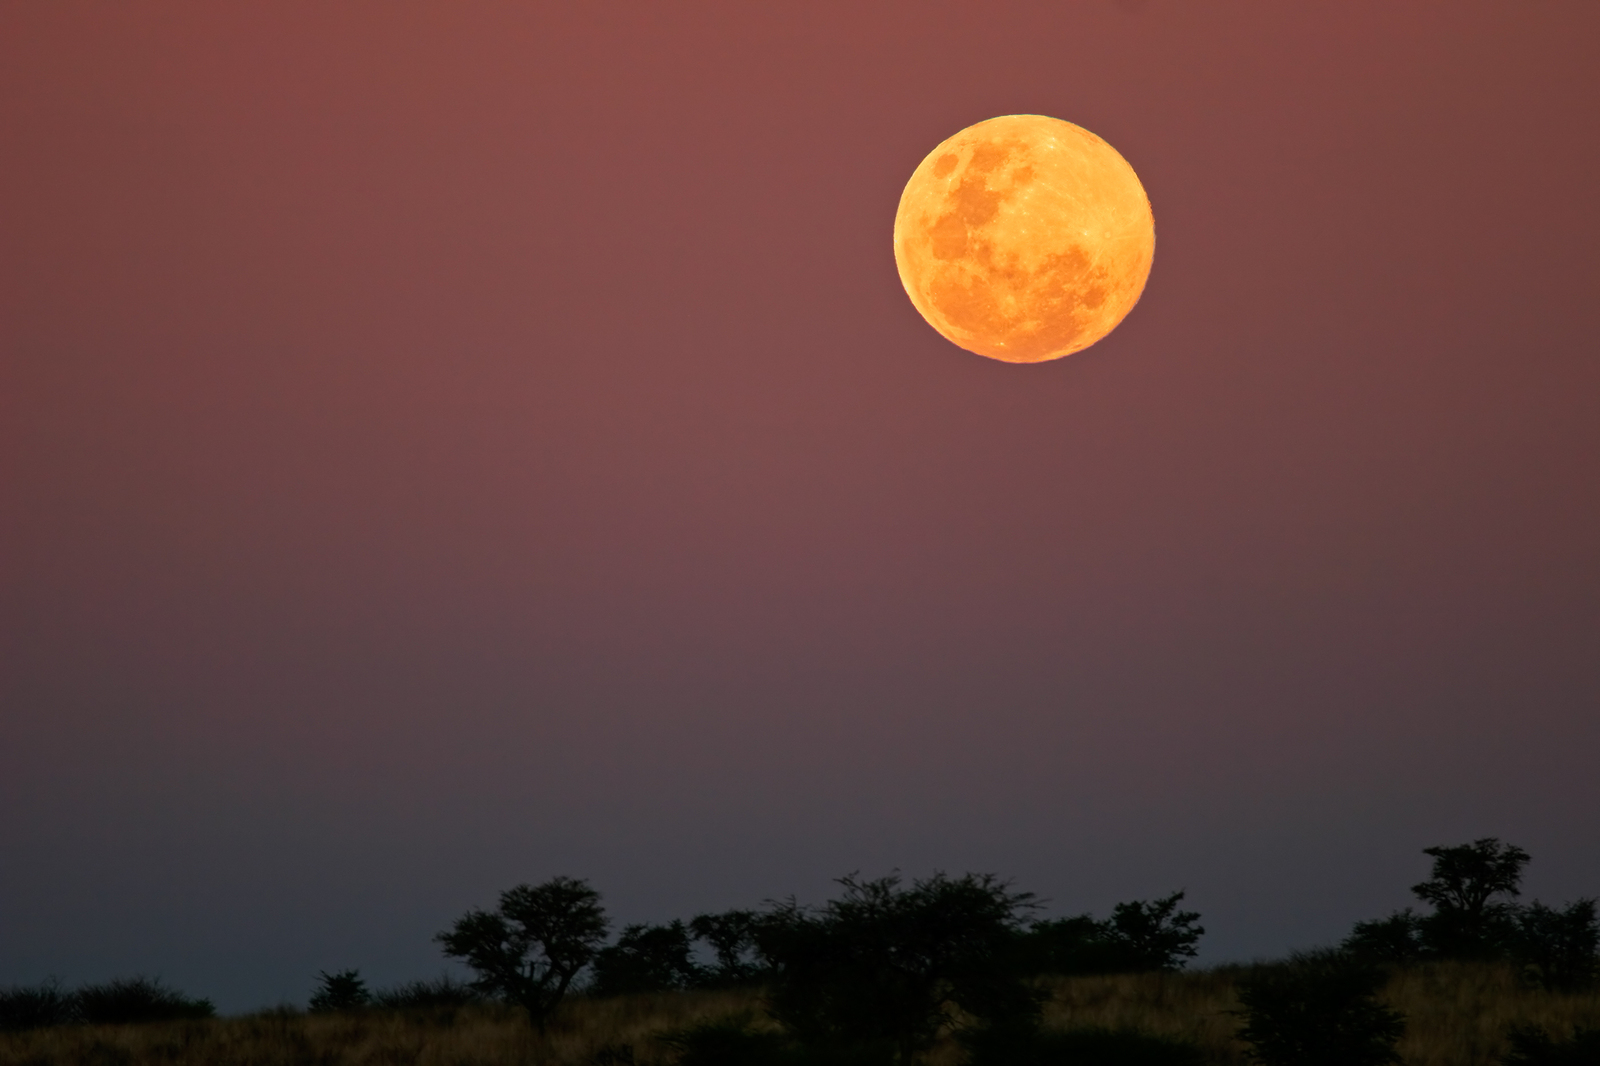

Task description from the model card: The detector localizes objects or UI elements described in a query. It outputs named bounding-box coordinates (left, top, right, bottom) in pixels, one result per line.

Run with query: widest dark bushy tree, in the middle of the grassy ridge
left=755, top=874, right=1038, bottom=1063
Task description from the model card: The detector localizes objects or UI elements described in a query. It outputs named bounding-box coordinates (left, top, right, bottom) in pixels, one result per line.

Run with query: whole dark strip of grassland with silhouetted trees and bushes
left=0, top=837, right=1600, bottom=1066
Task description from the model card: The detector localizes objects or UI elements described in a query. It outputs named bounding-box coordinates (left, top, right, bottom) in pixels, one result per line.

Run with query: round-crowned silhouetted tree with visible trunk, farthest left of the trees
left=434, top=877, right=608, bottom=1032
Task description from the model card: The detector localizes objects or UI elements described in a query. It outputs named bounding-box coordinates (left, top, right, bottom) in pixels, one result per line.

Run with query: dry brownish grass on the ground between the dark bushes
left=0, top=964, right=1600, bottom=1066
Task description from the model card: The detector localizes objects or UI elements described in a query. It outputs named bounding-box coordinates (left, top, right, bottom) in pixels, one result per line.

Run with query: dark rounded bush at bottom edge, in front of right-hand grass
left=1238, top=951, right=1405, bottom=1066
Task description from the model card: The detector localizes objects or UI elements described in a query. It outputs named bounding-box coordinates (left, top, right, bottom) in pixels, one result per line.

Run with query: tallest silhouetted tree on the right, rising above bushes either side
left=1411, top=837, right=1528, bottom=959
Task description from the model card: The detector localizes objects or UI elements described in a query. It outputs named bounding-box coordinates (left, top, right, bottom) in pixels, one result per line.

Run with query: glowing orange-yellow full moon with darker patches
left=894, top=115, right=1155, bottom=363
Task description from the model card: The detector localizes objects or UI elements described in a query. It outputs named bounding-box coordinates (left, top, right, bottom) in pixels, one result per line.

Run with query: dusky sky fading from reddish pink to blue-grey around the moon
left=0, top=0, right=1600, bottom=1012
